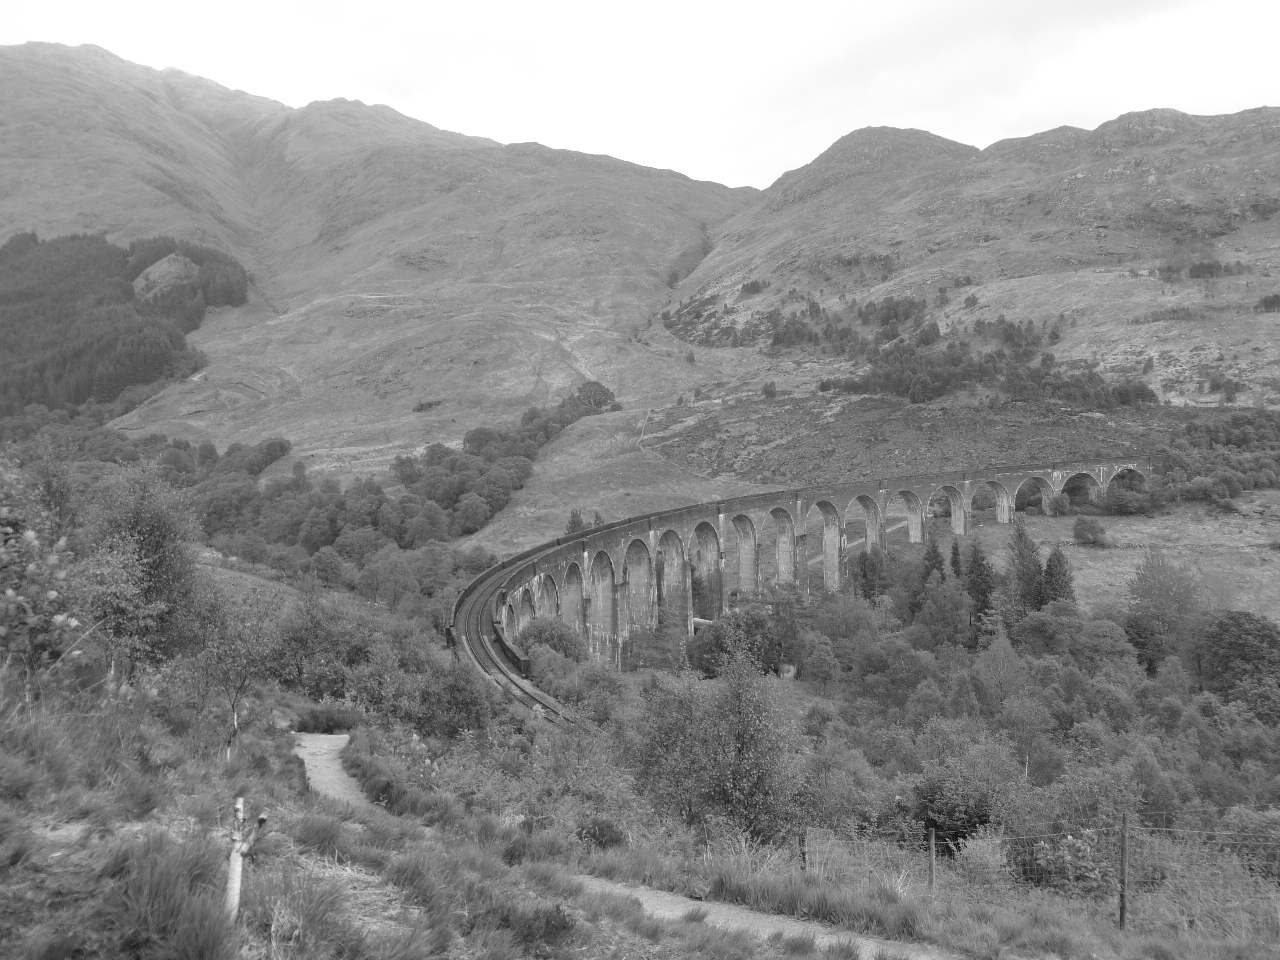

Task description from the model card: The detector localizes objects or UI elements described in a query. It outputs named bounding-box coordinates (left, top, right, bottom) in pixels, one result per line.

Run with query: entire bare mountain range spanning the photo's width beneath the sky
left=0, top=45, right=1280, bottom=512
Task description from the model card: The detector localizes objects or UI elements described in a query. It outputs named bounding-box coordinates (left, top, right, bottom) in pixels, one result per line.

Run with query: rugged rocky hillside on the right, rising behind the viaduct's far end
left=668, top=108, right=1280, bottom=403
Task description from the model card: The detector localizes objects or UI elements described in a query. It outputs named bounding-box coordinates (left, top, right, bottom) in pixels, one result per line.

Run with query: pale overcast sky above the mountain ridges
left=0, top=0, right=1280, bottom=187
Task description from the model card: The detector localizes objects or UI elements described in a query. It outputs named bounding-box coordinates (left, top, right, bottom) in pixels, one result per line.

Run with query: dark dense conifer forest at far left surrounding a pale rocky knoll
left=0, top=233, right=248, bottom=417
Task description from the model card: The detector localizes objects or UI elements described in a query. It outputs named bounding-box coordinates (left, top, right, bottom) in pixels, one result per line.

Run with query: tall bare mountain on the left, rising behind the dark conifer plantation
left=0, top=44, right=756, bottom=467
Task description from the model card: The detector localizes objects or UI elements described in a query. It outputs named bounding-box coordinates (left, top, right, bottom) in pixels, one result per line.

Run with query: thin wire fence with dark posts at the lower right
left=805, top=817, right=1280, bottom=942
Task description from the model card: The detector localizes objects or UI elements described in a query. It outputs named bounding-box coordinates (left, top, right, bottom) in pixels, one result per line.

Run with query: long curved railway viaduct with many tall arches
left=451, top=457, right=1157, bottom=686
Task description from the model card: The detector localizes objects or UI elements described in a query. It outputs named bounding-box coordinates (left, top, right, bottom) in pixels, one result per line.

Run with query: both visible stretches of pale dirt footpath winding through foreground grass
left=294, top=733, right=951, bottom=960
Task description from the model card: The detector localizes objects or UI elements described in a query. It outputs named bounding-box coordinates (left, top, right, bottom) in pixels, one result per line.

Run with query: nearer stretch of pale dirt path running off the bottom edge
left=576, top=877, right=952, bottom=960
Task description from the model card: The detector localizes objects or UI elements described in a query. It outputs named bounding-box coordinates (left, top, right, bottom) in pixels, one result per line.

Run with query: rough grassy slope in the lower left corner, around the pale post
left=0, top=698, right=860, bottom=960
